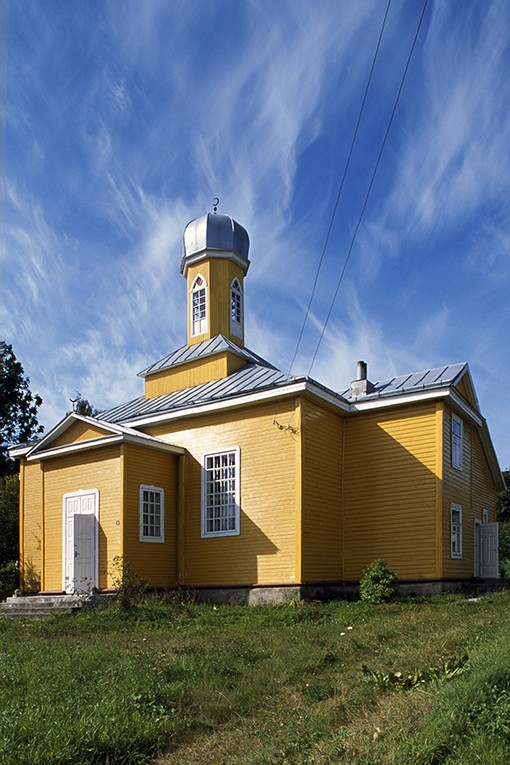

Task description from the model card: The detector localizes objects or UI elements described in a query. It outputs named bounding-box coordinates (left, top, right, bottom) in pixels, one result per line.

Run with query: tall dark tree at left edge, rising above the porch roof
left=0, top=341, right=43, bottom=476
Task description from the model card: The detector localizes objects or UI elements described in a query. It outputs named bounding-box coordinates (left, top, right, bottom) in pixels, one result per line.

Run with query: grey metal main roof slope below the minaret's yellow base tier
left=99, top=364, right=296, bottom=422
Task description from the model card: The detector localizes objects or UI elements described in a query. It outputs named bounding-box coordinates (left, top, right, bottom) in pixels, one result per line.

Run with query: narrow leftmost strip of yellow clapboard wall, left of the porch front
left=20, top=459, right=42, bottom=592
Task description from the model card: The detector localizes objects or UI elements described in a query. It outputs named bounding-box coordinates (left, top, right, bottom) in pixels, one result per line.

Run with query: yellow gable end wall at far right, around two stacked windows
left=443, top=409, right=497, bottom=578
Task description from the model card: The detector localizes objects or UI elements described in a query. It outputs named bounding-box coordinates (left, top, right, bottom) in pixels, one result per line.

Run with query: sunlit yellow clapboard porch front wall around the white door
left=42, top=445, right=121, bottom=590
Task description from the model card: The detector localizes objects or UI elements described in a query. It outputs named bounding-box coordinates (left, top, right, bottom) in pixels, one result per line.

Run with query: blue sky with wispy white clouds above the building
left=0, top=0, right=510, bottom=468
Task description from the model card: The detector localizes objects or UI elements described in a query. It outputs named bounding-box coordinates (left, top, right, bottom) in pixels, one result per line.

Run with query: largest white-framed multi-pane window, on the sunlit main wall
left=202, top=446, right=241, bottom=538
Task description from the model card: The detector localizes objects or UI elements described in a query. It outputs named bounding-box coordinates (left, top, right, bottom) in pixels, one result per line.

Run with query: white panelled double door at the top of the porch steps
left=63, top=489, right=99, bottom=592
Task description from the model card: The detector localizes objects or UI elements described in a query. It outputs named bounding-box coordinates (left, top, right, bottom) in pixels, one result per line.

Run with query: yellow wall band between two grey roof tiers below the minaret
left=145, top=351, right=246, bottom=398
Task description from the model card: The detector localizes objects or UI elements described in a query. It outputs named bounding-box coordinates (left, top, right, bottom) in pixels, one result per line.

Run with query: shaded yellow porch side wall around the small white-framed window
left=123, top=444, right=179, bottom=587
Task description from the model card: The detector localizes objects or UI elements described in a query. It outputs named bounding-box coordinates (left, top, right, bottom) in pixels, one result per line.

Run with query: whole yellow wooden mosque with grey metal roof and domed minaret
left=11, top=213, right=504, bottom=603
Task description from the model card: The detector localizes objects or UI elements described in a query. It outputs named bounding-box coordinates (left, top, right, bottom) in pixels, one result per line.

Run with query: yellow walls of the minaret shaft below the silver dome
left=188, top=258, right=244, bottom=347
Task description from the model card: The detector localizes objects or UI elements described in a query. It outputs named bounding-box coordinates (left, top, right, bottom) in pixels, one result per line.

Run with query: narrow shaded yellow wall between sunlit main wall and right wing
left=301, top=400, right=343, bottom=582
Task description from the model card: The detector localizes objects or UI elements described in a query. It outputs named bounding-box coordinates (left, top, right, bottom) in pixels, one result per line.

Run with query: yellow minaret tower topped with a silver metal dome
left=181, top=213, right=250, bottom=348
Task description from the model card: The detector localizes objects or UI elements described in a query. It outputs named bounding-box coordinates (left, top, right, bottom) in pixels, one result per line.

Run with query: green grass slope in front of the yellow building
left=0, top=592, right=510, bottom=765
